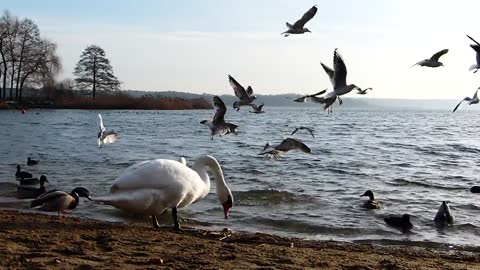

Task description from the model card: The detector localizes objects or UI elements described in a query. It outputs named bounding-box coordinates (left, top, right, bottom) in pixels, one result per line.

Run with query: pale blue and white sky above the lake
left=0, top=0, right=480, bottom=99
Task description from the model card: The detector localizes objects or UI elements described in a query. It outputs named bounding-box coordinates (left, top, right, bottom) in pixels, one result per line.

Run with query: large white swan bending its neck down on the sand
left=95, top=155, right=233, bottom=230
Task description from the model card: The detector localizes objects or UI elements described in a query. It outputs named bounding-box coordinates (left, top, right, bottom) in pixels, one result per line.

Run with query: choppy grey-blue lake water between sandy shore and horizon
left=0, top=107, right=480, bottom=249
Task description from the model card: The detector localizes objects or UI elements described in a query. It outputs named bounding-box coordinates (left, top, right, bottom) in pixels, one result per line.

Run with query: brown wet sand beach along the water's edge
left=0, top=211, right=480, bottom=270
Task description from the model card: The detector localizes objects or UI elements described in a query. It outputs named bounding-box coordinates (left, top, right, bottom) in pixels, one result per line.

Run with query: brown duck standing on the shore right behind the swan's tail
left=30, top=187, right=92, bottom=218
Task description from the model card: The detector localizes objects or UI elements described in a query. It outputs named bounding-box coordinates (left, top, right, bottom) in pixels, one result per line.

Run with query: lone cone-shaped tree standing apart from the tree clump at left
left=73, top=45, right=120, bottom=99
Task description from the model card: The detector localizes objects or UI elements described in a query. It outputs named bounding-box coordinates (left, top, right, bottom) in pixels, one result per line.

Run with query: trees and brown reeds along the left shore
left=0, top=11, right=212, bottom=109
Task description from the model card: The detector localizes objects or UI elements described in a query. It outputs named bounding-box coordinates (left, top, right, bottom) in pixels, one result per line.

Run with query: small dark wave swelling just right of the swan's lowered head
left=234, top=189, right=315, bottom=206
